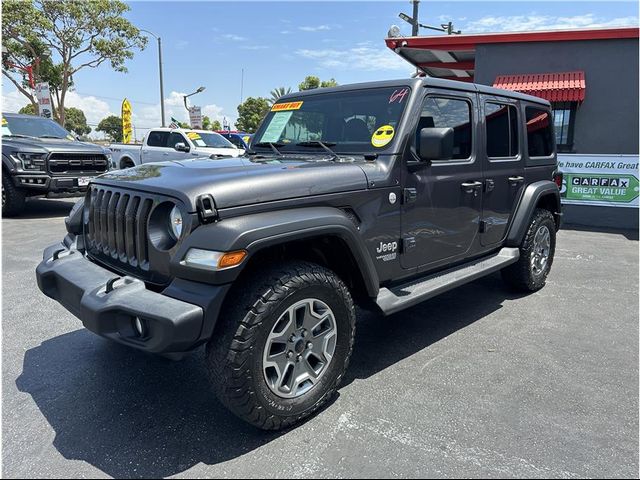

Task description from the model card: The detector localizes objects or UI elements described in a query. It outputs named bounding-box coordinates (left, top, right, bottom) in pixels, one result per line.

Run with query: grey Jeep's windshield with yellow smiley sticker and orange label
left=252, top=87, right=410, bottom=153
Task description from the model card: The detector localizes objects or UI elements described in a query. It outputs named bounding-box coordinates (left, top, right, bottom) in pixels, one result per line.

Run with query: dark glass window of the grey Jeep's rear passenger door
left=484, top=102, right=518, bottom=158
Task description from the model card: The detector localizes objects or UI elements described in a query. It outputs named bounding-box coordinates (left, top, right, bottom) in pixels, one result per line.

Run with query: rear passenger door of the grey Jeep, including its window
left=478, top=95, right=525, bottom=247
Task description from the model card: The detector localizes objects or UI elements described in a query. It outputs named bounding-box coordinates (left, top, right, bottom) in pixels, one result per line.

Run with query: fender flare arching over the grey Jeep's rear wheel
left=505, top=180, right=562, bottom=247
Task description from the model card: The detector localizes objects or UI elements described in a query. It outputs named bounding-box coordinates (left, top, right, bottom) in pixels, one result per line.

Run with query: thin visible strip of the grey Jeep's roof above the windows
left=278, top=77, right=550, bottom=106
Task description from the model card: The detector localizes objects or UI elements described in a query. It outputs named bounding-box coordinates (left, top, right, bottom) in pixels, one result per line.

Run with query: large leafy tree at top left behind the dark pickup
left=2, top=0, right=147, bottom=125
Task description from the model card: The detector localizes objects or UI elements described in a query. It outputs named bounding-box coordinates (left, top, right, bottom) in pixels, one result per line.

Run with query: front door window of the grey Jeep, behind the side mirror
left=416, top=97, right=473, bottom=160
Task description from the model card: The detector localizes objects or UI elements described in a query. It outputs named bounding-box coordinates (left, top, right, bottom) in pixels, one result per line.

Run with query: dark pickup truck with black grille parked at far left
left=2, top=113, right=111, bottom=216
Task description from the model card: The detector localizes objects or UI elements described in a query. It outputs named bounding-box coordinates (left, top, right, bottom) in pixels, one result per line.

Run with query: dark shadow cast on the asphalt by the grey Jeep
left=16, top=275, right=515, bottom=478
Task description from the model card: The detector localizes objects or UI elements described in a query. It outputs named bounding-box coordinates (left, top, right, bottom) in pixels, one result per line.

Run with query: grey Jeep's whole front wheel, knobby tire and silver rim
left=207, top=262, right=355, bottom=430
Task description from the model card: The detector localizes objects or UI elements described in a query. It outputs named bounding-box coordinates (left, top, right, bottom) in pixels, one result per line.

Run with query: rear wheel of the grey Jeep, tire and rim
left=502, top=208, right=556, bottom=292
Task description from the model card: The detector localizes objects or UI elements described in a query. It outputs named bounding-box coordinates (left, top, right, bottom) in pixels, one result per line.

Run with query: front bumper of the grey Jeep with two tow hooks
left=36, top=242, right=226, bottom=353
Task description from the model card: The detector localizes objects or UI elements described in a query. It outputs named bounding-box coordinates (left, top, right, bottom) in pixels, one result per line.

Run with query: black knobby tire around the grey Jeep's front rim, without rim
left=206, top=262, right=355, bottom=430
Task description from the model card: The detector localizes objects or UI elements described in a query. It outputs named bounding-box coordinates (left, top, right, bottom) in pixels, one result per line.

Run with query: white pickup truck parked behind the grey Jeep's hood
left=109, top=128, right=244, bottom=168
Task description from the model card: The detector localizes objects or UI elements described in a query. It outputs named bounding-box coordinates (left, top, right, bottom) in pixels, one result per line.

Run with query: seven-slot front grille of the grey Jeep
left=85, top=185, right=154, bottom=276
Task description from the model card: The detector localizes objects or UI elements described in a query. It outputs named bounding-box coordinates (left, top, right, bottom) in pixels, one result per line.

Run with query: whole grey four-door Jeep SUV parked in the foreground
left=37, top=78, right=561, bottom=429
